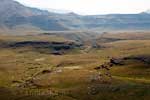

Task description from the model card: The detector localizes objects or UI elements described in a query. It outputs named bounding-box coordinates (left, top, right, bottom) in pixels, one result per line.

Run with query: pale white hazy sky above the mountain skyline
left=17, top=0, right=150, bottom=15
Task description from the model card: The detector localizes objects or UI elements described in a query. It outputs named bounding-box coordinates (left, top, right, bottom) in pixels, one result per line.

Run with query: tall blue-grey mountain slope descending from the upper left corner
left=0, top=0, right=66, bottom=30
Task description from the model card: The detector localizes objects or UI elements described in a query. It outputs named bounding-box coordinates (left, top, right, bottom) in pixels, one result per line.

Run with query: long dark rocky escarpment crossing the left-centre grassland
left=5, top=41, right=82, bottom=55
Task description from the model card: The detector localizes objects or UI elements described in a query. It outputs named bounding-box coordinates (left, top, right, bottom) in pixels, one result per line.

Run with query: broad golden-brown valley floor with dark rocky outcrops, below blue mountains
left=0, top=32, right=150, bottom=100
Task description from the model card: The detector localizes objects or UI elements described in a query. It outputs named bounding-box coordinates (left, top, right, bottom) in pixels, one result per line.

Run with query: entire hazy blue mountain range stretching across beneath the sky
left=0, top=0, right=150, bottom=34
